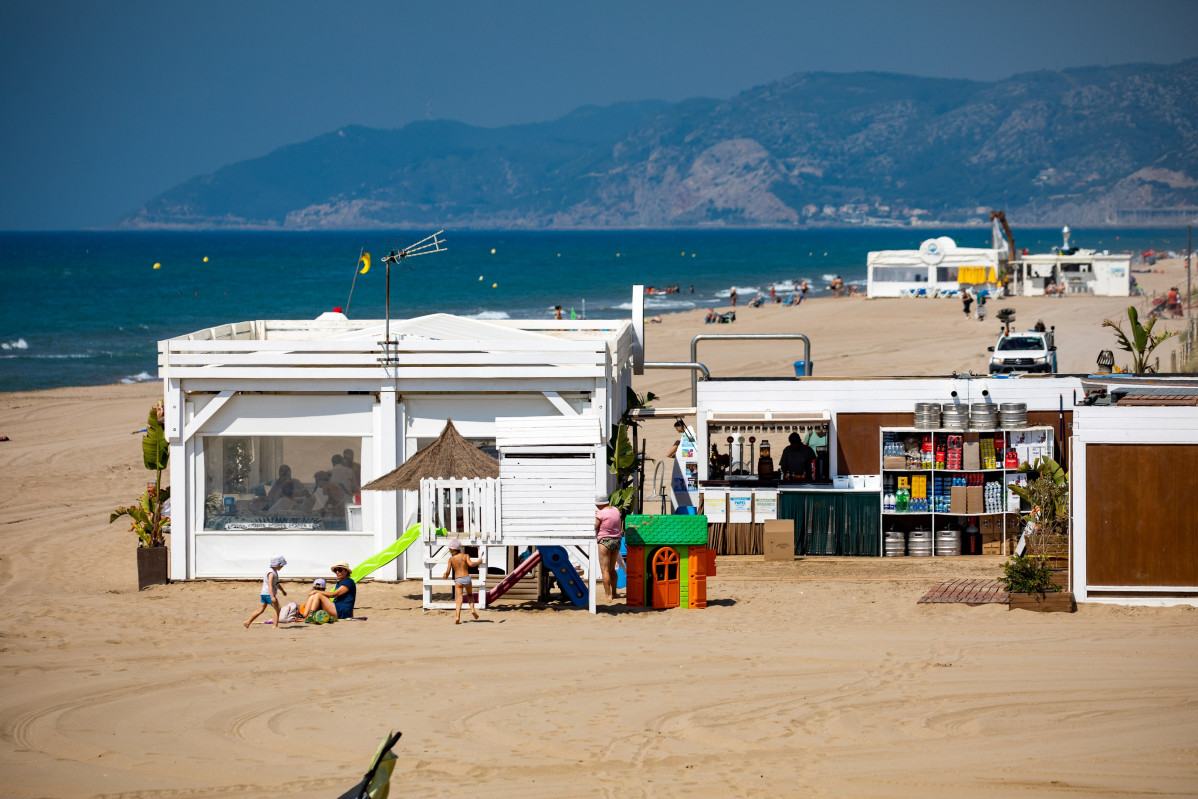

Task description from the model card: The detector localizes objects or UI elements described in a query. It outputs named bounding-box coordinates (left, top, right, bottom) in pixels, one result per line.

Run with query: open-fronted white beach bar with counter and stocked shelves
left=696, top=375, right=1082, bottom=556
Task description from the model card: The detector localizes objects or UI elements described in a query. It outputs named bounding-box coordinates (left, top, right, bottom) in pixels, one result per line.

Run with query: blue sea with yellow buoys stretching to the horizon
left=0, top=228, right=1185, bottom=392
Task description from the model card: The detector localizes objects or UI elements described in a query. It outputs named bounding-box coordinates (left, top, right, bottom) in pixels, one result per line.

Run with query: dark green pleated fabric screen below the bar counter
left=778, top=491, right=882, bottom=557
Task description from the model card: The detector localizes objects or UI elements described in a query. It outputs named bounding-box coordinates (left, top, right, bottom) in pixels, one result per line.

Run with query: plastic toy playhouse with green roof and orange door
left=624, top=515, right=715, bottom=607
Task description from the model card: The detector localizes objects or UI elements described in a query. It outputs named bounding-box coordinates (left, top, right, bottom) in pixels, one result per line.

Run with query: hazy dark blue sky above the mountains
left=0, top=0, right=1198, bottom=230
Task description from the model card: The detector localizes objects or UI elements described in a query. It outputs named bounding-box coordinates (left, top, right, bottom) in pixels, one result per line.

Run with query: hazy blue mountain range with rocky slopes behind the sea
left=116, top=59, right=1198, bottom=230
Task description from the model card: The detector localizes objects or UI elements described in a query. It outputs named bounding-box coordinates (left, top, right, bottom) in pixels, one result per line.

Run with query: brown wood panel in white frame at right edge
left=1085, top=444, right=1198, bottom=586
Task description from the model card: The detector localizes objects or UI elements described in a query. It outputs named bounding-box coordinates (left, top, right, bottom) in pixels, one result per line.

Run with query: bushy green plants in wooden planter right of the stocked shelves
left=998, top=458, right=1076, bottom=611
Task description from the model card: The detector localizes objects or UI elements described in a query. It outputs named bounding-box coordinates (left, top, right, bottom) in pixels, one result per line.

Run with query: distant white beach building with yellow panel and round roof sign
left=866, top=236, right=1008, bottom=297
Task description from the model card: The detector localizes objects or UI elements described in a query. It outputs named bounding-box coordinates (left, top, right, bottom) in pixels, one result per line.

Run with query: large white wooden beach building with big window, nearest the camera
left=158, top=314, right=634, bottom=606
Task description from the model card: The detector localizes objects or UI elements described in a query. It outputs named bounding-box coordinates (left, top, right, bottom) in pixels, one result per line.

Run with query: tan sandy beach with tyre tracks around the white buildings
left=0, top=261, right=1198, bottom=799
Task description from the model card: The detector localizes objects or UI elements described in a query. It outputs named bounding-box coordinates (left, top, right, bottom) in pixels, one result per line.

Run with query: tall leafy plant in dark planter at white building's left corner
left=108, top=402, right=170, bottom=591
